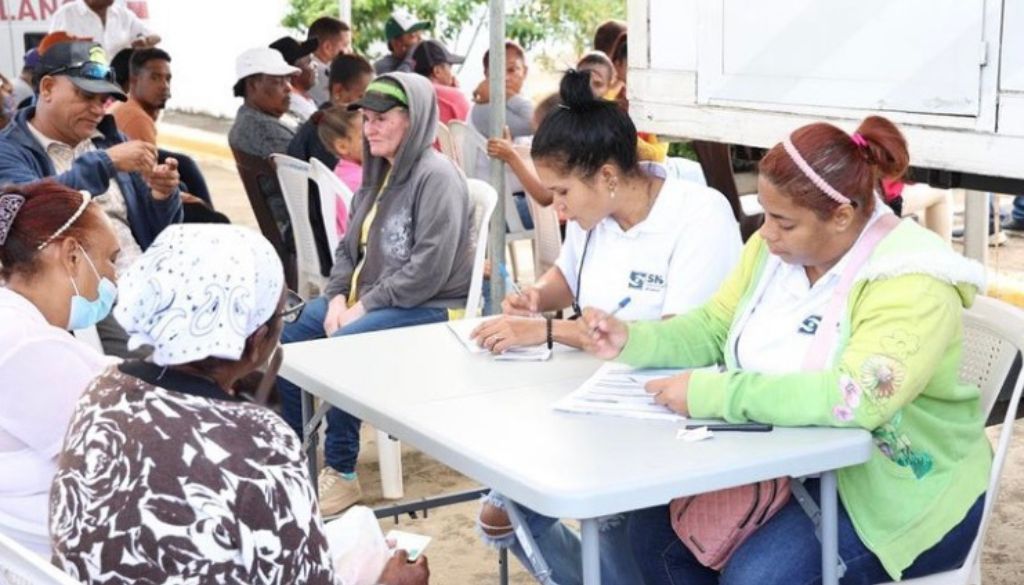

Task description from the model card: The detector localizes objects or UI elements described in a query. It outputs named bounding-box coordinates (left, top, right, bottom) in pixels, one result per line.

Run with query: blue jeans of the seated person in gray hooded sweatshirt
left=278, top=296, right=447, bottom=473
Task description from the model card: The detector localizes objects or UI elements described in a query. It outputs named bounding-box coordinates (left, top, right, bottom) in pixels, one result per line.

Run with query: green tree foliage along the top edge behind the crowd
left=283, top=0, right=626, bottom=53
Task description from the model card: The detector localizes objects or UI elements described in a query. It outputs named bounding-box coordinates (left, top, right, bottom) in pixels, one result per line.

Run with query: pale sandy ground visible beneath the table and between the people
left=186, top=154, right=1024, bottom=585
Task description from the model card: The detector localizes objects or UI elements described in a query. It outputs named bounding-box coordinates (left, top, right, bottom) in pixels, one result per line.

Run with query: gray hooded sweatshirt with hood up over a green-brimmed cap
left=325, top=73, right=473, bottom=311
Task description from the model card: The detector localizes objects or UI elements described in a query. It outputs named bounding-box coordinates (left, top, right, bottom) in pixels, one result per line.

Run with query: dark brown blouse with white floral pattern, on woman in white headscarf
left=50, top=362, right=335, bottom=585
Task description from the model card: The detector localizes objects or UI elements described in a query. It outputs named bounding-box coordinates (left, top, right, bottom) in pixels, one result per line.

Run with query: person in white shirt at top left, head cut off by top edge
left=50, top=0, right=160, bottom=55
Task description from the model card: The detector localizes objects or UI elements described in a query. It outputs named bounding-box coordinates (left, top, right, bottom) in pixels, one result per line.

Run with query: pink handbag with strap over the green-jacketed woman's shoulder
left=669, top=214, right=899, bottom=571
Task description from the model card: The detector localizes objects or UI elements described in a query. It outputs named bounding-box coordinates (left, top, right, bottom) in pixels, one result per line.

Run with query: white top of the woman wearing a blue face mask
left=0, top=287, right=112, bottom=558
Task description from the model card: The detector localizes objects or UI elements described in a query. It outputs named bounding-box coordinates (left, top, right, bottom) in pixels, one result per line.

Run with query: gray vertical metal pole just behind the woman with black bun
left=487, top=0, right=508, bottom=310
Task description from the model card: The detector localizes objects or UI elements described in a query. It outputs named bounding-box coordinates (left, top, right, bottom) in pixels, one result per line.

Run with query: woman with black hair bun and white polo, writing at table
left=474, top=72, right=742, bottom=585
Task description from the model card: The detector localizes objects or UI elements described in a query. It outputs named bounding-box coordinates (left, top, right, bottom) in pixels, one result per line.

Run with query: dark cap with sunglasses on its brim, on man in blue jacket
left=36, top=41, right=128, bottom=101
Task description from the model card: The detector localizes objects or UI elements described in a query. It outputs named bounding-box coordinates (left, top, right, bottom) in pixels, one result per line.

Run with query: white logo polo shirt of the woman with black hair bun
left=555, top=174, right=742, bottom=321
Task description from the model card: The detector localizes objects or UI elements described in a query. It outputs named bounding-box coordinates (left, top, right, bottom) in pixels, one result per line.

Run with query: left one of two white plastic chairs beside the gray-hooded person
left=270, top=153, right=321, bottom=299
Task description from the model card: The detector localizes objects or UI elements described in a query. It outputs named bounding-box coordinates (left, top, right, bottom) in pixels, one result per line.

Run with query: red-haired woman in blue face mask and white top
left=0, top=180, right=120, bottom=557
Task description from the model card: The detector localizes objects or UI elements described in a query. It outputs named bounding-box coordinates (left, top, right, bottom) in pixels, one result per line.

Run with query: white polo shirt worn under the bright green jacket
left=732, top=201, right=892, bottom=374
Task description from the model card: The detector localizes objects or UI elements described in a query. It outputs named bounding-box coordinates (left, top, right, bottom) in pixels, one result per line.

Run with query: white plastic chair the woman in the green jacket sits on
left=876, top=297, right=1024, bottom=585
